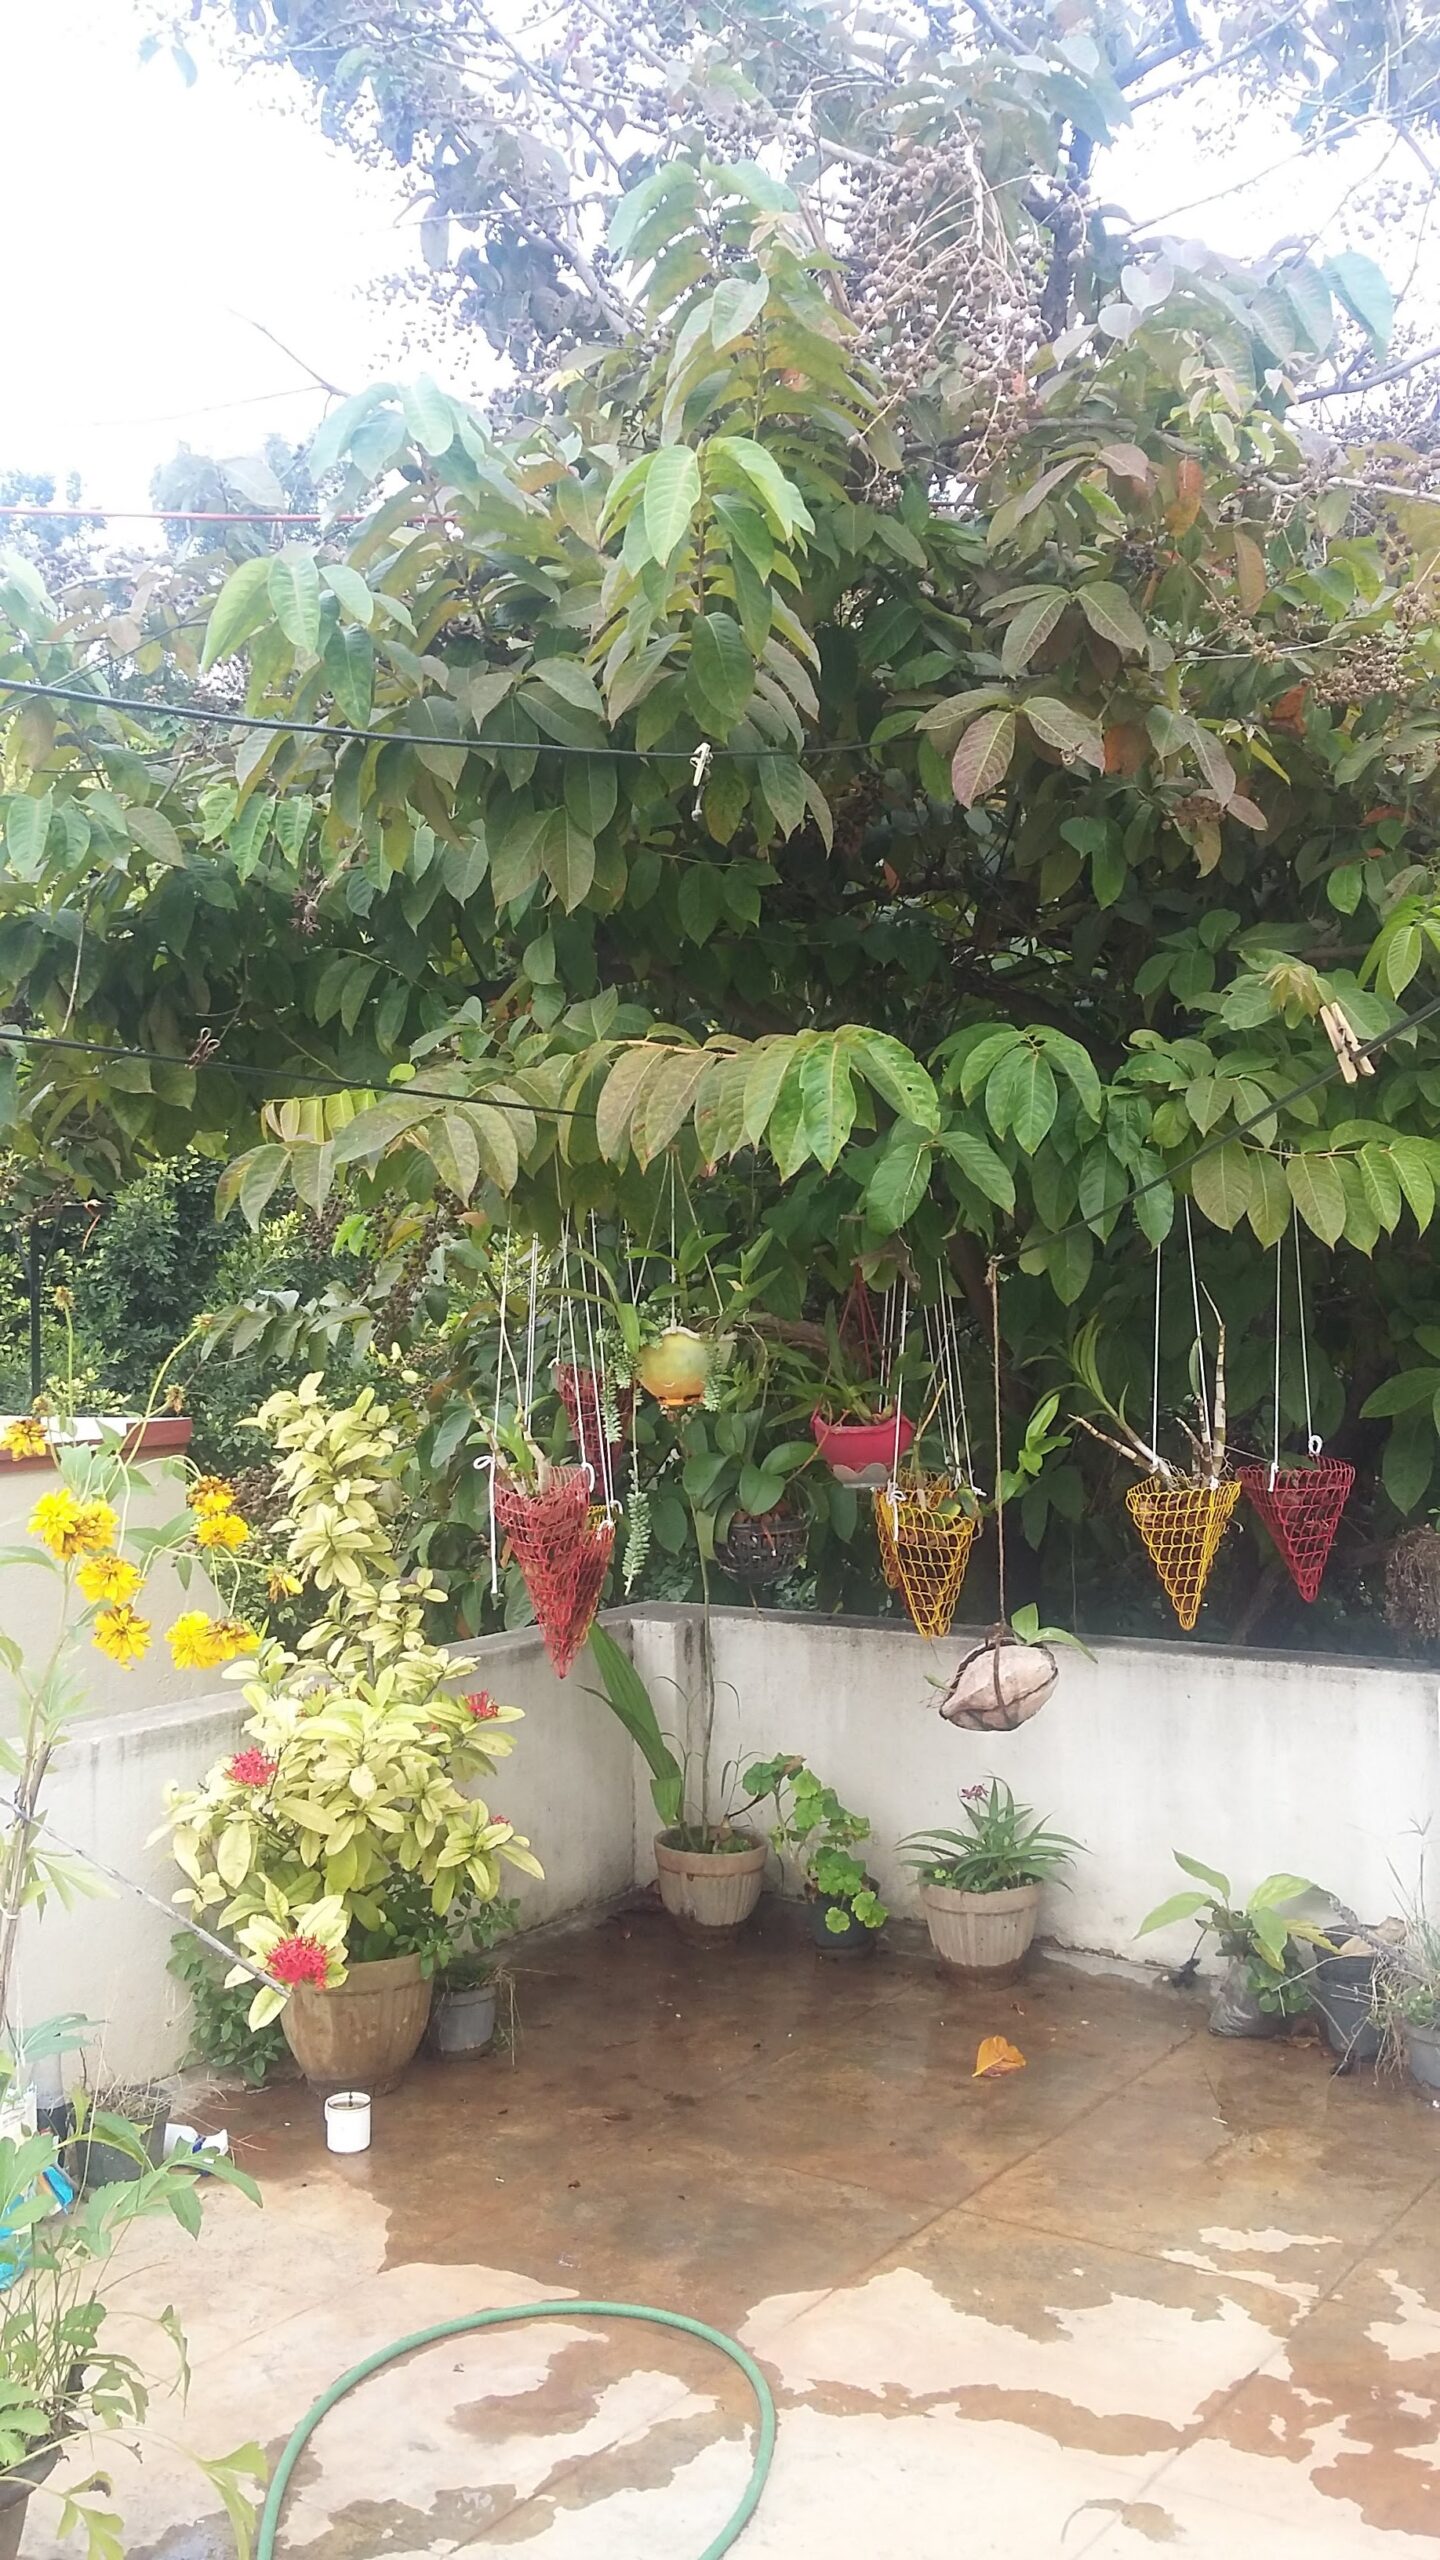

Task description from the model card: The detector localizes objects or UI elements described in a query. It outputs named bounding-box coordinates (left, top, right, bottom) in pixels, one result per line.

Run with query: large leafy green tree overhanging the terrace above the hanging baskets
left=0, top=0, right=1440, bottom=1628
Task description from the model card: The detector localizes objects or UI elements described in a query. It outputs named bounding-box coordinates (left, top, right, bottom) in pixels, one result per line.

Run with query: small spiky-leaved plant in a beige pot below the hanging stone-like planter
left=899, top=1777, right=1079, bottom=1981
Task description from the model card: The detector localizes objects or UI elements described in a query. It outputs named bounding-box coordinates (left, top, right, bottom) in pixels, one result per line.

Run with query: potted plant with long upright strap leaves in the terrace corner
left=589, top=1626, right=769, bottom=1946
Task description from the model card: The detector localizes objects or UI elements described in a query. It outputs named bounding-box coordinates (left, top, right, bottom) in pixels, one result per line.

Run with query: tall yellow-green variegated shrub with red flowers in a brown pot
left=167, top=1377, right=541, bottom=2094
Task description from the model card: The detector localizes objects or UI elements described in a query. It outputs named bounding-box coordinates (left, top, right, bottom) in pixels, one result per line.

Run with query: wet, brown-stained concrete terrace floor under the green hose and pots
left=26, top=1907, right=1440, bottom=2560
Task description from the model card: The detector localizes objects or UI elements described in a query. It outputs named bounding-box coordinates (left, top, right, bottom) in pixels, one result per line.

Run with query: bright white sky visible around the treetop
left=0, top=0, right=1440, bottom=514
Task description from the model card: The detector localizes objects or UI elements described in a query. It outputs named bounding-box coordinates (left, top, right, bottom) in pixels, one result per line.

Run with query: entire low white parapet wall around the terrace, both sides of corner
left=23, top=1608, right=1440, bottom=2076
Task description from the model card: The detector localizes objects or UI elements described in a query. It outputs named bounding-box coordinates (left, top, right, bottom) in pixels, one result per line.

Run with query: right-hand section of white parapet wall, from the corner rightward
left=633, top=1610, right=1440, bottom=1961
